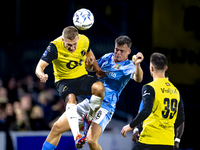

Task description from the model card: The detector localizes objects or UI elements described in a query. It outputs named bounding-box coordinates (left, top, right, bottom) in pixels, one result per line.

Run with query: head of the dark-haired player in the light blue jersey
left=114, top=36, right=132, bottom=62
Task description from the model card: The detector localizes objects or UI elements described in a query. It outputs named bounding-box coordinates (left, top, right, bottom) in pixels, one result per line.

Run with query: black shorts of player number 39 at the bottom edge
left=131, top=142, right=173, bottom=150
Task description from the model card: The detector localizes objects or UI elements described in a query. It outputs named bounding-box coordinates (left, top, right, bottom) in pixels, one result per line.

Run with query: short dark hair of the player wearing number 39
left=150, top=53, right=167, bottom=70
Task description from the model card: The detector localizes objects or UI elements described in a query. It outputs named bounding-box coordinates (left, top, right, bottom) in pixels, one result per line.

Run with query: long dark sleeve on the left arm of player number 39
left=130, top=85, right=155, bottom=128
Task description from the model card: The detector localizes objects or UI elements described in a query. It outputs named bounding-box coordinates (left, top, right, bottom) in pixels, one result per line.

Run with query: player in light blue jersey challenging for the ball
left=77, top=36, right=144, bottom=150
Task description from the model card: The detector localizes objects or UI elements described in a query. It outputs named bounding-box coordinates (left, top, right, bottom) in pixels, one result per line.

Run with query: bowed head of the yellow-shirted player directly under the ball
left=62, top=26, right=79, bottom=53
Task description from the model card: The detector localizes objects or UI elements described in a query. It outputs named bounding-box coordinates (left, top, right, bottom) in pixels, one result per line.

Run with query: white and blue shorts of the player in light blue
left=77, top=98, right=113, bottom=132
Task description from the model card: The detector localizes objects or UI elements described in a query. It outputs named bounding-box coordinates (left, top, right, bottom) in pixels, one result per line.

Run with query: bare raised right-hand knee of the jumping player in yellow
left=92, top=82, right=105, bottom=97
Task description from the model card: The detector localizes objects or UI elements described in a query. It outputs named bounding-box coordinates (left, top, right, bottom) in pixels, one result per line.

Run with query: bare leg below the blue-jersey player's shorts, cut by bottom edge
left=87, top=122, right=102, bottom=150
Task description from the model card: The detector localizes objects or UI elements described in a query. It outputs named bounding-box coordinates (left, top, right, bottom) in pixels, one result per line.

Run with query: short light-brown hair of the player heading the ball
left=62, top=26, right=78, bottom=40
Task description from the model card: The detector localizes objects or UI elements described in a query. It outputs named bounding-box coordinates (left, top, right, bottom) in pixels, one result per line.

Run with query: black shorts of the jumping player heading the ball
left=55, top=75, right=99, bottom=100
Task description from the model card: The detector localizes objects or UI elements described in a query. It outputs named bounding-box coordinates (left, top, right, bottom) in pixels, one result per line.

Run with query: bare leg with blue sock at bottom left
left=42, top=110, right=70, bottom=150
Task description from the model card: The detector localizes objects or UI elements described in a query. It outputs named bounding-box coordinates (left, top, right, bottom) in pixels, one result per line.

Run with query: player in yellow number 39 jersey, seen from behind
left=121, top=53, right=184, bottom=150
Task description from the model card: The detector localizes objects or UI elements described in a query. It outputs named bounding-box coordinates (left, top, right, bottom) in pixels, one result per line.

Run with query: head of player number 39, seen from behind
left=150, top=53, right=167, bottom=75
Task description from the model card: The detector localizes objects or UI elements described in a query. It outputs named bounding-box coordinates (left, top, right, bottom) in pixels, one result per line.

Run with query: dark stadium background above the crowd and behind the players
left=0, top=0, right=200, bottom=149
